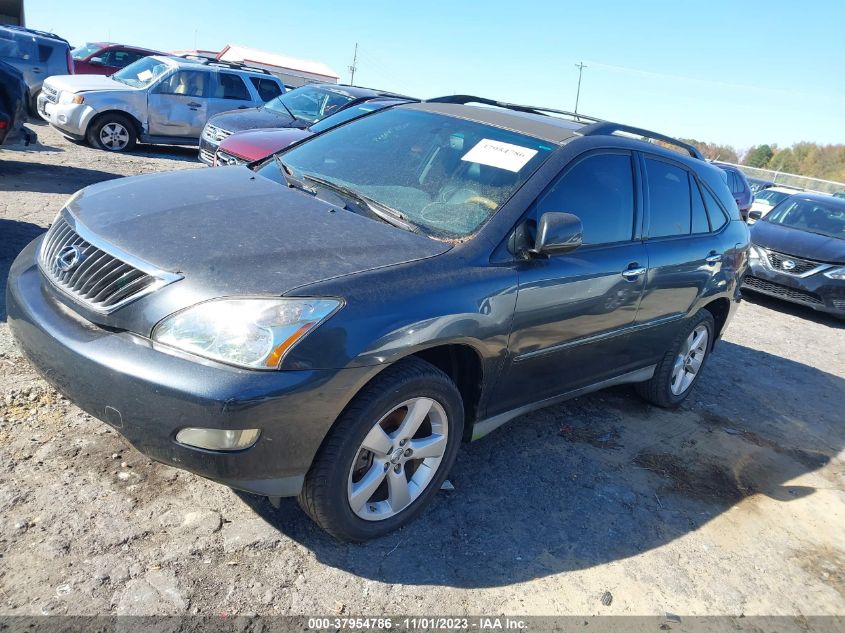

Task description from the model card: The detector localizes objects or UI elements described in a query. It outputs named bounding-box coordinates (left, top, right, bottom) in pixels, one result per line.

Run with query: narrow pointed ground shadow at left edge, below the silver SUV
left=0, top=157, right=121, bottom=195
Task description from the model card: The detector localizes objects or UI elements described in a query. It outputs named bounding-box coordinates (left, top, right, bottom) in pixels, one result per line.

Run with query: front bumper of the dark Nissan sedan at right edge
left=742, top=259, right=845, bottom=316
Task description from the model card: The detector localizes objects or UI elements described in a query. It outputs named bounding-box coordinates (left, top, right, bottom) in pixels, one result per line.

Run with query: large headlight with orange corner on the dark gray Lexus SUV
left=152, top=299, right=341, bottom=369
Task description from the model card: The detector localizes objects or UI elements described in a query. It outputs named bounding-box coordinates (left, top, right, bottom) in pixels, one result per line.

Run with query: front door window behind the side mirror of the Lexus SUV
left=536, top=154, right=634, bottom=244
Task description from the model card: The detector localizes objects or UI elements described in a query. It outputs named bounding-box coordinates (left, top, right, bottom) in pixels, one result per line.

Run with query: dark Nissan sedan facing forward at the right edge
left=742, top=193, right=845, bottom=318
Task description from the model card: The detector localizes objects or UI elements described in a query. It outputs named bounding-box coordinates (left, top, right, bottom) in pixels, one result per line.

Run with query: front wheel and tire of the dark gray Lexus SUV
left=299, top=358, right=464, bottom=541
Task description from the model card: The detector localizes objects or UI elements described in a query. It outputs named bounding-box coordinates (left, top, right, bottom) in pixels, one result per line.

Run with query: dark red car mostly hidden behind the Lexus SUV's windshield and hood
left=213, top=97, right=413, bottom=167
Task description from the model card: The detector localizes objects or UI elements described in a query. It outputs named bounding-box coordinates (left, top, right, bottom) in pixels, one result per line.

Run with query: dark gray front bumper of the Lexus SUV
left=6, top=240, right=378, bottom=496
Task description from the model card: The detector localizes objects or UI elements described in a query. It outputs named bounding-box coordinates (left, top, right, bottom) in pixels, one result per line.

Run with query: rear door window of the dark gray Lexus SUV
left=645, top=158, right=691, bottom=237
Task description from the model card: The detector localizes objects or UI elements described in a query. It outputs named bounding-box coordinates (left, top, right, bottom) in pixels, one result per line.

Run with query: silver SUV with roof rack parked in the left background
left=37, top=55, right=285, bottom=152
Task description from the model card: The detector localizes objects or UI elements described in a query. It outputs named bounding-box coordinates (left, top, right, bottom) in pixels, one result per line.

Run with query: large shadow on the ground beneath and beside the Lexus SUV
left=241, top=342, right=845, bottom=588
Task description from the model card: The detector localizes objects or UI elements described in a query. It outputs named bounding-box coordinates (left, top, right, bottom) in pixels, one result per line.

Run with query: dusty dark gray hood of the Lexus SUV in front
left=68, top=167, right=450, bottom=298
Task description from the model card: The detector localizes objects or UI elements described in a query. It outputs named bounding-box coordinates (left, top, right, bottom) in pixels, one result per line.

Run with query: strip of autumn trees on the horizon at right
left=683, top=139, right=845, bottom=182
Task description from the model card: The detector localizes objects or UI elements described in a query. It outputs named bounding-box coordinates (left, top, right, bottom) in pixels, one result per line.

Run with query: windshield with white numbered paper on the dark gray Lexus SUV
left=258, top=109, right=554, bottom=239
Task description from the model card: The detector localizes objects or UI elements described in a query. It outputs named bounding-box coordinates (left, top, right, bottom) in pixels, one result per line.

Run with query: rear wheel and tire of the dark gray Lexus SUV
left=635, top=308, right=716, bottom=409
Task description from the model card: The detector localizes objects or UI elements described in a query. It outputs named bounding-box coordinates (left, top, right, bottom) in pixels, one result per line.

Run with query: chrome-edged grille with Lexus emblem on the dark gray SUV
left=38, top=212, right=181, bottom=314
